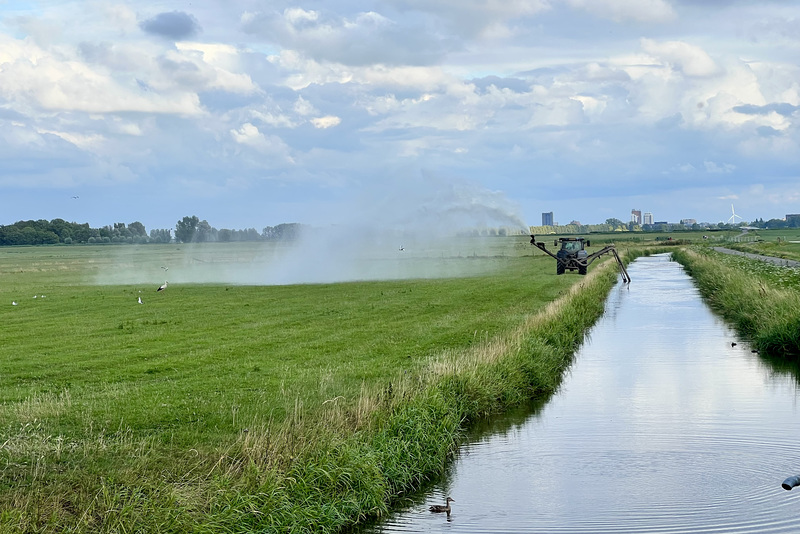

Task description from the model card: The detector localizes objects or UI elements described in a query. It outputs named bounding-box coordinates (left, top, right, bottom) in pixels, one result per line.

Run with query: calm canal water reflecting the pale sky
left=368, top=255, right=800, bottom=534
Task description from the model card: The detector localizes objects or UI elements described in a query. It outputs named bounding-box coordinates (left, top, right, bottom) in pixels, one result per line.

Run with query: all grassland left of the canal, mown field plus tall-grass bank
left=0, top=239, right=616, bottom=532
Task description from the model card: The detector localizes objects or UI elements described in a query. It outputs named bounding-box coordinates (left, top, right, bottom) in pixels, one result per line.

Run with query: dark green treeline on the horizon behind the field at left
left=0, top=216, right=308, bottom=246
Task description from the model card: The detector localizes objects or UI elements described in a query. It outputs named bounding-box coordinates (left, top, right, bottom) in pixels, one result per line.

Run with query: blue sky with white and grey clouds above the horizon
left=0, top=0, right=800, bottom=230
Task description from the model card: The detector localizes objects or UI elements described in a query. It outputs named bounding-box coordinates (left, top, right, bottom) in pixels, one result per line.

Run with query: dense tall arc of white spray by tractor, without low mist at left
left=261, top=176, right=529, bottom=284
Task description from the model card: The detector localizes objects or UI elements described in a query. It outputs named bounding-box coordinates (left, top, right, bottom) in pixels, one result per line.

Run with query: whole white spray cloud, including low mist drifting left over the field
left=95, top=174, right=528, bottom=287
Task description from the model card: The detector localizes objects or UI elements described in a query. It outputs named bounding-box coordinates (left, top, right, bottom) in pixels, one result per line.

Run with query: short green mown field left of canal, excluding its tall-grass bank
left=0, top=239, right=574, bottom=445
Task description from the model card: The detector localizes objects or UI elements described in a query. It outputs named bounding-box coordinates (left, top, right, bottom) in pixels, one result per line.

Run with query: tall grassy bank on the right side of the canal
left=673, top=248, right=800, bottom=361
